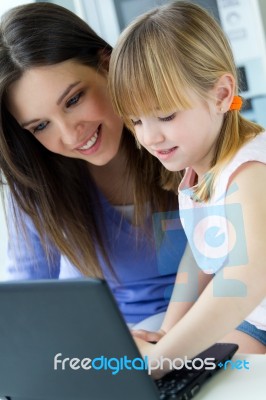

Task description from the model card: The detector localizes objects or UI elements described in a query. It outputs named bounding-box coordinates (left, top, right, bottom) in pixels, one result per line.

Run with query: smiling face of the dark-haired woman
left=8, top=60, right=123, bottom=165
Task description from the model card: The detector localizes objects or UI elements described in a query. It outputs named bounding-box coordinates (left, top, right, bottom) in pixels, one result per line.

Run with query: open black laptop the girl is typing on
left=0, top=279, right=237, bottom=400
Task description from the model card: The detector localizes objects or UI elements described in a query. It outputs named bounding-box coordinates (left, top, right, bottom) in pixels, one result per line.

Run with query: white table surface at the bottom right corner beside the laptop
left=194, top=354, right=266, bottom=400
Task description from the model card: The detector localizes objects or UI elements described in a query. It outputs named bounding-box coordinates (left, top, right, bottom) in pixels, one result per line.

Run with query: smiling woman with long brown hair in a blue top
left=0, top=3, right=186, bottom=323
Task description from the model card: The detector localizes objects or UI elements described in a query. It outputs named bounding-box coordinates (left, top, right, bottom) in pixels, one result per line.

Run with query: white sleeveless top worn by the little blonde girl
left=179, top=132, right=266, bottom=330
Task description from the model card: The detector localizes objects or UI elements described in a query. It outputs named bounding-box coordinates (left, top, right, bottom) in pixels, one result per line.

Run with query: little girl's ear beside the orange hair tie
left=214, top=74, right=236, bottom=113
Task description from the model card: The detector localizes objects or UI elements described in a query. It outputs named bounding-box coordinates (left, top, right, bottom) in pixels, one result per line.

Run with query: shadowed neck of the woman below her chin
left=89, top=148, right=133, bottom=205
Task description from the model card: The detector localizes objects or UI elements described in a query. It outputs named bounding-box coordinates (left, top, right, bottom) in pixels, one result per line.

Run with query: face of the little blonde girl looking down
left=131, top=91, right=223, bottom=176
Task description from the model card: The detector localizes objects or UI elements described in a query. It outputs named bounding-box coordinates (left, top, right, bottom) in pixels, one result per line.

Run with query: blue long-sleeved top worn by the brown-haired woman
left=6, top=192, right=186, bottom=323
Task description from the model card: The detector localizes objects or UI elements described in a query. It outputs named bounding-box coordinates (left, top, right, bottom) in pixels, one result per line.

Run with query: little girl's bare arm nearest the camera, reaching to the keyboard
left=138, top=162, right=266, bottom=377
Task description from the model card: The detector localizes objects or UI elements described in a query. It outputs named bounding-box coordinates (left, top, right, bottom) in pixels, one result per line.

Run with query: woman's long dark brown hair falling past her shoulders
left=0, top=3, right=180, bottom=276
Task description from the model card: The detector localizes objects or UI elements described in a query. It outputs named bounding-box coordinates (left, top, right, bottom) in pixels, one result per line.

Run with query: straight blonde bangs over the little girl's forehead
left=110, top=27, right=191, bottom=129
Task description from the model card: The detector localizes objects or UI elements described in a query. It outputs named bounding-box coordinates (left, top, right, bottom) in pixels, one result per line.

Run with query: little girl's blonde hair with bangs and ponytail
left=109, top=1, right=263, bottom=201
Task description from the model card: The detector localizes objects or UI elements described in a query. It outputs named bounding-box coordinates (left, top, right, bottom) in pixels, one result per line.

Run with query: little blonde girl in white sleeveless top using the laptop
left=109, top=1, right=266, bottom=376
